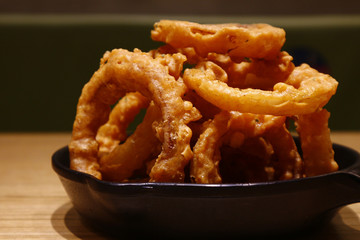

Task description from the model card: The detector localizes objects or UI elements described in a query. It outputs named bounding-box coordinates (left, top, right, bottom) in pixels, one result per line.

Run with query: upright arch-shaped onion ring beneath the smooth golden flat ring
left=190, top=111, right=302, bottom=183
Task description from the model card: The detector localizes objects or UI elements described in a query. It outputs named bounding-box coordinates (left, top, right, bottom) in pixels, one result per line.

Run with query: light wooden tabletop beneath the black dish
left=0, top=132, right=360, bottom=240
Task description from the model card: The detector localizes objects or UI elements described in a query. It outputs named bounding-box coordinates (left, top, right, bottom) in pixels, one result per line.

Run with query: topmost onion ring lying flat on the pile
left=151, top=20, right=285, bottom=59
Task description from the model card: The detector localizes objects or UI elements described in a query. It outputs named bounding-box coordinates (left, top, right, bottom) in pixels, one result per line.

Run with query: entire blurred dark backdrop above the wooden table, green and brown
left=0, top=0, right=360, bottom=132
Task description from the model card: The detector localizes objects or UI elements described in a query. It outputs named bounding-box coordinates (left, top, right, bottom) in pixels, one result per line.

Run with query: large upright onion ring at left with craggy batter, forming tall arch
left=69, top=49, right=195, bottom=182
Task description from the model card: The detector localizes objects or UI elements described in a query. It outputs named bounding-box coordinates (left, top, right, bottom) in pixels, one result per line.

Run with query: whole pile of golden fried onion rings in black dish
left=69, top=20, right=338, bottom=183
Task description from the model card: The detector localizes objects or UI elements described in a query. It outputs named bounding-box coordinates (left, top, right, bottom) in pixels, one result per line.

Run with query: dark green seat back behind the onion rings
left=0, top=15, right=360, bottom=132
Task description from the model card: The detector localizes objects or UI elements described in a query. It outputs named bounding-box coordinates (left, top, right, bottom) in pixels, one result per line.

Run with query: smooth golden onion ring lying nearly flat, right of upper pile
left=183, top=62, right=338, bottom=116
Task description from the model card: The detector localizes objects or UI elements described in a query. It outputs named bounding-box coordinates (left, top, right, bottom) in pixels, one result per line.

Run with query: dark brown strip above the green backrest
left=0, top=0, right=360, bottom=15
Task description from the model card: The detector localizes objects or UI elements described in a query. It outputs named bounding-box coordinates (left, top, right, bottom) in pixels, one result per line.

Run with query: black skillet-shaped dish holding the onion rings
left=52, top=138, right=360, bottom=236
